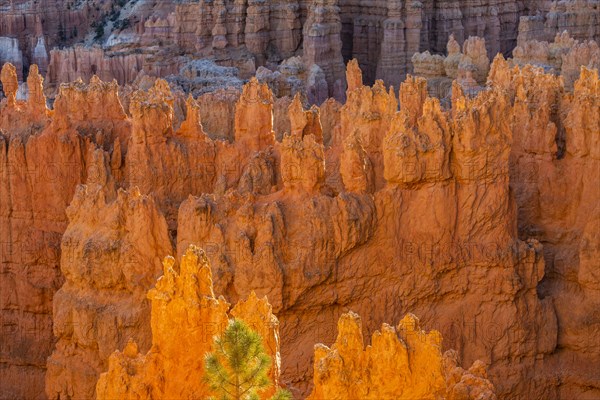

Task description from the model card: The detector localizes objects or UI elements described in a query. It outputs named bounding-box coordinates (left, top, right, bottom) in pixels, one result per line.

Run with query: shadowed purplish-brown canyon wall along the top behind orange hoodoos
left=0, top=0, right=600, bottom=97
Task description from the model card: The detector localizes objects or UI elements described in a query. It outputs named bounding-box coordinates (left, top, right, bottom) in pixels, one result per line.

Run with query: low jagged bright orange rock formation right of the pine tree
left=308, top=312, right=496, bottom=400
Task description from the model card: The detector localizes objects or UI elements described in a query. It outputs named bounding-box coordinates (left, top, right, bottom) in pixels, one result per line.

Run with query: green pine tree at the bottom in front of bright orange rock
left=205, top=319, right=292, bottom=400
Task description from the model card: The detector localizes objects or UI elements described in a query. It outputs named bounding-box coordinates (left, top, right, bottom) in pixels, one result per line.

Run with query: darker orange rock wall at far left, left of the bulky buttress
left=0, top=66, right=104, bottom=398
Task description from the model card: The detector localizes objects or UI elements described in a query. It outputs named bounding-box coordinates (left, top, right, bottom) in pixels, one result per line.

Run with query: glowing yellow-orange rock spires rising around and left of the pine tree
left=96, top=246, right=280, bottom=400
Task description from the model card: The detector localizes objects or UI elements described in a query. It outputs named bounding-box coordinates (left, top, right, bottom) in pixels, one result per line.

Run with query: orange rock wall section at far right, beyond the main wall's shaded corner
left=497, top=62, right=600, bottom=398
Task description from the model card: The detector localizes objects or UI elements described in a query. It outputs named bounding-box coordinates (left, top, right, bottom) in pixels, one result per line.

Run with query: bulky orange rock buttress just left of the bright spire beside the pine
left=46, top=186, right=171, bottom=399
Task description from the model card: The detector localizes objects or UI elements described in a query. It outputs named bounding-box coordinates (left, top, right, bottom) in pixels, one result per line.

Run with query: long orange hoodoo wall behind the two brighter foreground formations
left=0, top=57, right=600, bottom=398
